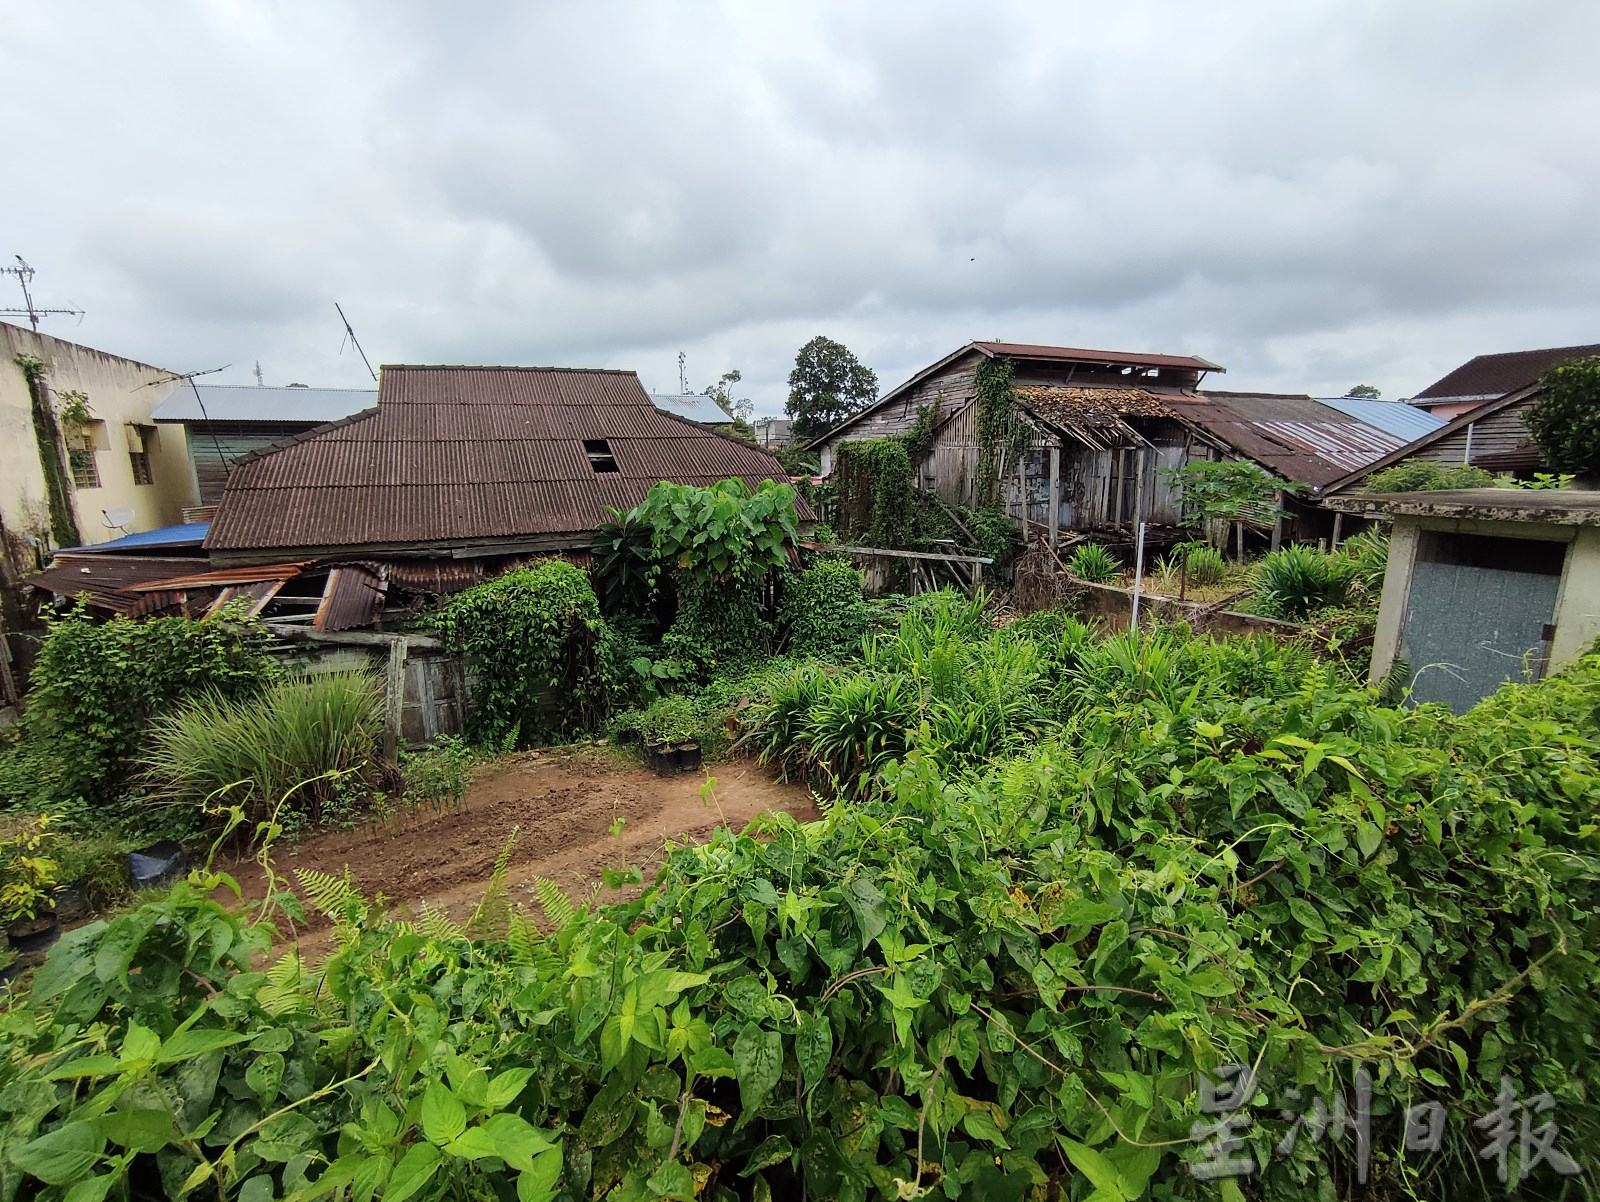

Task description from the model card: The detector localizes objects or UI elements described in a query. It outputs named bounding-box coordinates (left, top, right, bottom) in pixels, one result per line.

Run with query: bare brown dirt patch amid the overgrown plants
left=229, top=747, right=819, bottom=956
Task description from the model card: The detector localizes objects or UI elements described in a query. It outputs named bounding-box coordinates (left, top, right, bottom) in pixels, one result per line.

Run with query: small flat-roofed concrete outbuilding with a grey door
left=1323, top=488, right=1600, bottom=714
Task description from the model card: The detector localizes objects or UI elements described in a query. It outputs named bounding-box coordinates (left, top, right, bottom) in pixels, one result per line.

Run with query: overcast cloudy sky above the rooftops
left=0, top=0, right=1600, bottom=413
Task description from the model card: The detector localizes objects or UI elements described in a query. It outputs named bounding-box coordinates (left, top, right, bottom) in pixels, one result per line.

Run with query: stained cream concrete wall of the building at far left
left=0, top=322, right=195, bottom=568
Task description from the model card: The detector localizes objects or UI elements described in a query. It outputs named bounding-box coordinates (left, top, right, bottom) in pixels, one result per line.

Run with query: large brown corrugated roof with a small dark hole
left=206, top=367, right=813, bottom=551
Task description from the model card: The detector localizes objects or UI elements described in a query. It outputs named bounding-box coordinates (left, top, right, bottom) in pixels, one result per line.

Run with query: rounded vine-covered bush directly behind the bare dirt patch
left=430, top=559, right=606, bottom=747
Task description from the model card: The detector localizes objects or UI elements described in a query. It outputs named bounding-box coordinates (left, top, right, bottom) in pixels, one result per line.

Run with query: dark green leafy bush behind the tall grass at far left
left=0, top=607, right=277, bottom=810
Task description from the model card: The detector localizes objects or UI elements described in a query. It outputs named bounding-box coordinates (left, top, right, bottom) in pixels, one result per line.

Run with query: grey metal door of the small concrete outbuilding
left=1400, top=560, right=1560, bottom=714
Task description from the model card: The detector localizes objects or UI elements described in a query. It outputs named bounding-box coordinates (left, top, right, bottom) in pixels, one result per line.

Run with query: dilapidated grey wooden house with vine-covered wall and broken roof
left=813, top=343, right=1403, bottom=543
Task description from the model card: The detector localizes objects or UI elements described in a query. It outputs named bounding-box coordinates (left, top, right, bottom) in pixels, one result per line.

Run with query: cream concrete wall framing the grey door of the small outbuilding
left=1371, top=515, right=1600, bottom=683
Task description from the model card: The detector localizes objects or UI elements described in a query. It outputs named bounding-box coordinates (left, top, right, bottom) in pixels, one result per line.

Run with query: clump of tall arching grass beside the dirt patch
left=144, top=672, right=384, bottom=821
